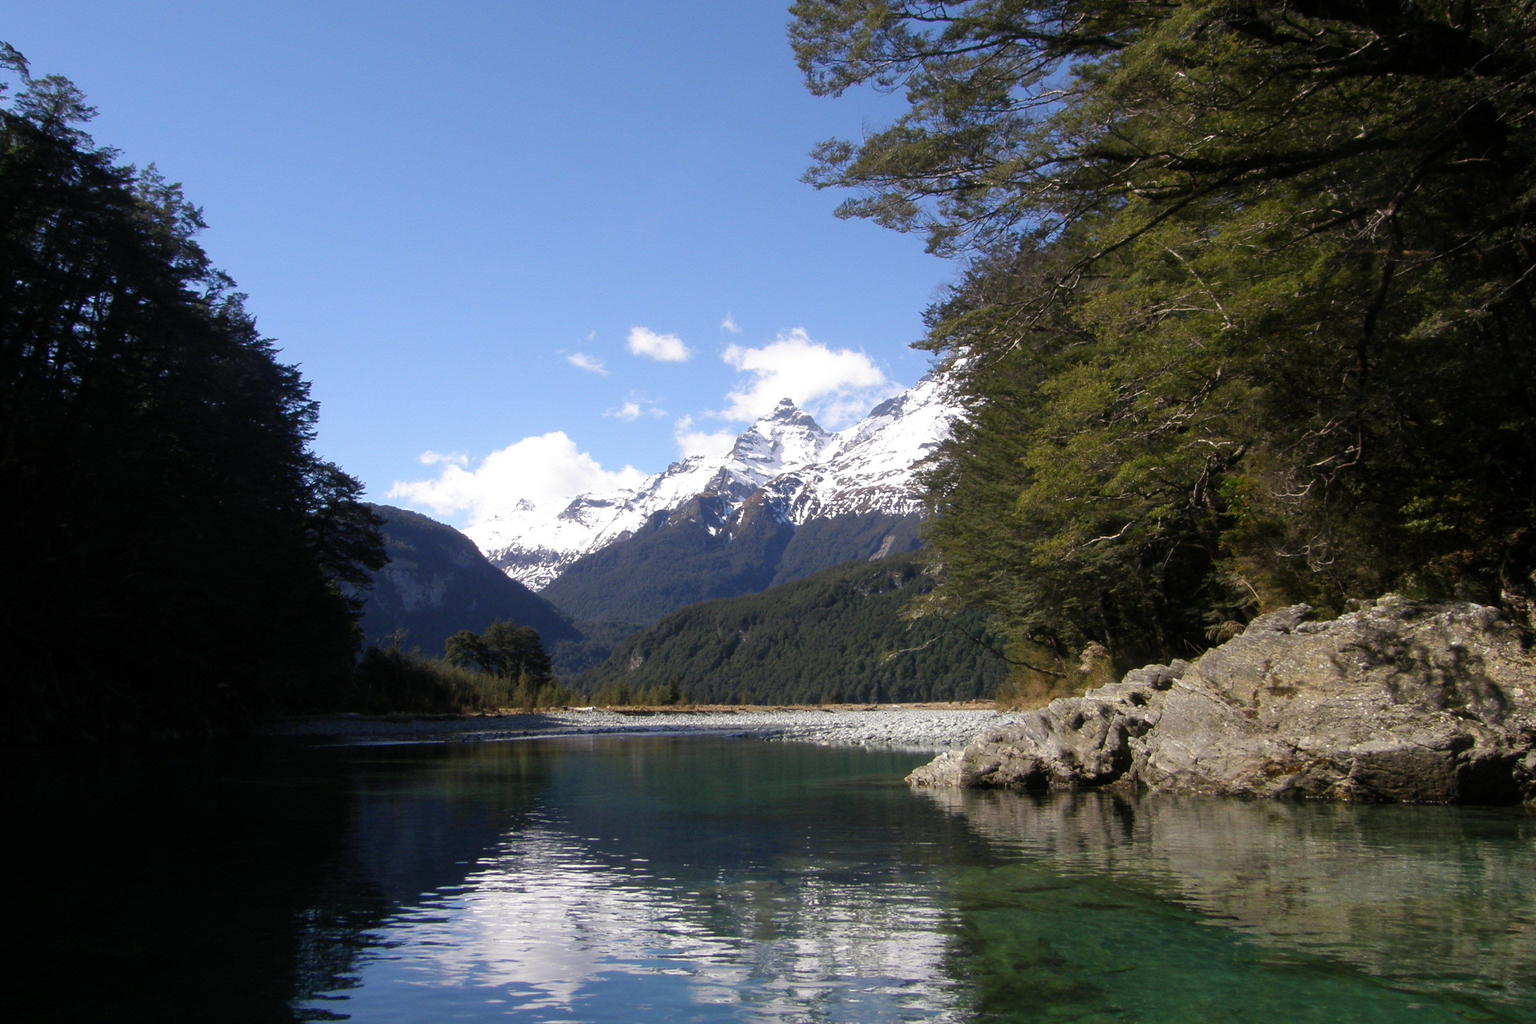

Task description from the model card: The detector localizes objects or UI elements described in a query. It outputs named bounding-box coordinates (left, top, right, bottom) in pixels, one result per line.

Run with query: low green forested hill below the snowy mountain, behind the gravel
left=576, top=554, right=1008, bottom=703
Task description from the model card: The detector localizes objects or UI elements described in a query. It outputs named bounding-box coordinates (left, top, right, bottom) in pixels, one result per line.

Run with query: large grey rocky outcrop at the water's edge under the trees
left=908, top=597, right=1536, bottom=803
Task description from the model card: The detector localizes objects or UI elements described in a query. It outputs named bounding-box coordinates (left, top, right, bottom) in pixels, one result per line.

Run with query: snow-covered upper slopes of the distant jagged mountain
left=464, top=373, right=958, bottom=590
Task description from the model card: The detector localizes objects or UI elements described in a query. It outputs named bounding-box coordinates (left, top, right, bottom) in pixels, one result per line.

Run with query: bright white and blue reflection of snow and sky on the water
left=305, top=820, right=957, bottom=1021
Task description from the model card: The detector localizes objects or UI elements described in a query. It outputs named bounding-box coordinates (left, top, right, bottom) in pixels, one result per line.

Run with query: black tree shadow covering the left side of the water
left=3, top=742, right=556, bottom=1021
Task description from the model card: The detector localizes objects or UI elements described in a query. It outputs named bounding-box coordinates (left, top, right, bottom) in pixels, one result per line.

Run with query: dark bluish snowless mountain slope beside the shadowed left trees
left=361, top=505, right=579, bottom=666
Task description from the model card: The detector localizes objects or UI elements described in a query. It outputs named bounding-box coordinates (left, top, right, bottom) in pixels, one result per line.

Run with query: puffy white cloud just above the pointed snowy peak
left=716, top=327, right=900, bottom=430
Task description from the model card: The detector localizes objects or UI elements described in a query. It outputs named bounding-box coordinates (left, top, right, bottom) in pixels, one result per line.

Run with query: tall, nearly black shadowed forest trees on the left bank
left=0, top=45, right=382, bottom=738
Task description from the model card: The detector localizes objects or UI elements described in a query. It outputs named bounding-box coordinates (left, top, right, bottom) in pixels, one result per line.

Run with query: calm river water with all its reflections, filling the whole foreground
left=6, top=737, right=1536, bottom=1024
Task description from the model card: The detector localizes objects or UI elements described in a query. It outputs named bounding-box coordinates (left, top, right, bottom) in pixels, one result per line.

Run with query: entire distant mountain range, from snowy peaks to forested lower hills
left=354, top=376, right=1001, bottom=700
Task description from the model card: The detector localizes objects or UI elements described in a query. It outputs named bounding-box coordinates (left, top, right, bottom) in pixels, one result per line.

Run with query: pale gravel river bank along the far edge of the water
left=272, top=705, right=1009, bottom=752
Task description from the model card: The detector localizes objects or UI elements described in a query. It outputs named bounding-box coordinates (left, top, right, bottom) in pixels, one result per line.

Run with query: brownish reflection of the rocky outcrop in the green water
left=925, top=791, right=1536, bottom=1004
